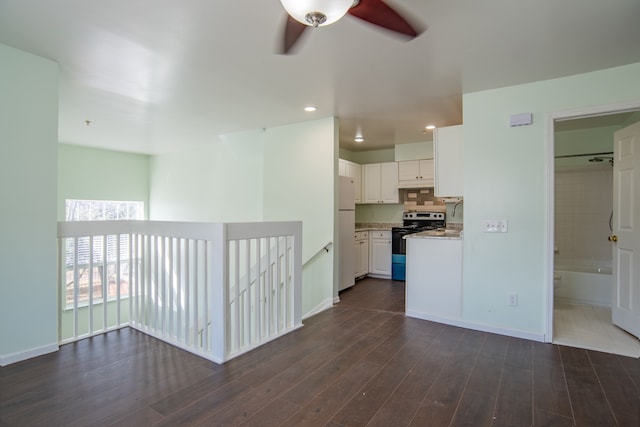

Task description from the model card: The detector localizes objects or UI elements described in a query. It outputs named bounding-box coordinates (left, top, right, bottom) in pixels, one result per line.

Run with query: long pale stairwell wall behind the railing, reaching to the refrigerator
left=150, top=117, right=337, bottom=315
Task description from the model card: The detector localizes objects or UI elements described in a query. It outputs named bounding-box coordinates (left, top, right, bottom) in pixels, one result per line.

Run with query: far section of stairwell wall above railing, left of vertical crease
left=149, top=130, right=264, bottom=222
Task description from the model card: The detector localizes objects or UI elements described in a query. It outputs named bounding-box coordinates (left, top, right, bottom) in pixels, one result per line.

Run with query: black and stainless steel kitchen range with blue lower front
left=391, top=212, right=446, bottom=280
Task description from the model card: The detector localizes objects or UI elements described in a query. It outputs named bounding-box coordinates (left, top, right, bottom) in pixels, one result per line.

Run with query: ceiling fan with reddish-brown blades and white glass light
left=280, top=0, right=423, bottom=54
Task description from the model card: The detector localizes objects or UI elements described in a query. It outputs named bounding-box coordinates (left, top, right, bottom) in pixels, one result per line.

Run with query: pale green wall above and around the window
left=58, top=144, right=149, bottom=221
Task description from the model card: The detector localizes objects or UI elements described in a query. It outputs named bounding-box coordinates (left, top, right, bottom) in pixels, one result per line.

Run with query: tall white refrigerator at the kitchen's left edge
left=338, top=176, right=356, bottom=291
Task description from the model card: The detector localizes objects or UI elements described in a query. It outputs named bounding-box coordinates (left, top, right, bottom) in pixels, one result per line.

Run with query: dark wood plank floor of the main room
left=0, top=279, right=640, bottom=427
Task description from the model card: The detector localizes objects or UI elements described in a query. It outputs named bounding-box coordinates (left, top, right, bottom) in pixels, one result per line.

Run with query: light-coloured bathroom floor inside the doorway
left=553, top=302, right=640, bottom=358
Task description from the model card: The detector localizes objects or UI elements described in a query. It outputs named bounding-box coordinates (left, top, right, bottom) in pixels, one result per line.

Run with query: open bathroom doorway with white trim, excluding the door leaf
left=547, top=103, right=640, bottom=357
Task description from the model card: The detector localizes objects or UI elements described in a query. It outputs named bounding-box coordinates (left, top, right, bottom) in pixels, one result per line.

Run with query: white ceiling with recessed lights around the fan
left=0, top=0, right=640, bottom=154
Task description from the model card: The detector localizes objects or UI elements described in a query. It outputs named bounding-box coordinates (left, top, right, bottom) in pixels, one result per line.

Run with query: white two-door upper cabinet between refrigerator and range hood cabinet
left=362, top=162, right=399, bottom=203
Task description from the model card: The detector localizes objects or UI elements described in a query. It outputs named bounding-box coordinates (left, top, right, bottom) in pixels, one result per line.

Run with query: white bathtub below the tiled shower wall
left=554, top=265, right=612, bottom=307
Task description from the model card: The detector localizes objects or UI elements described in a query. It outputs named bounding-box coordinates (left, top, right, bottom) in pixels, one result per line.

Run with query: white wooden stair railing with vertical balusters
left=58, top=221, right=302, bottom=363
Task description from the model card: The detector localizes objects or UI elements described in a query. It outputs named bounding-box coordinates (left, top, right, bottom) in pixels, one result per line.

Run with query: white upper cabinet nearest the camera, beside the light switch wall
left=433, top=125, right=464, bottom=197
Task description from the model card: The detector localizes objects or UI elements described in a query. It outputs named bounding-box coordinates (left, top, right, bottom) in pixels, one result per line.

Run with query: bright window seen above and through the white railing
left=65, top=199, right=144, bottom=306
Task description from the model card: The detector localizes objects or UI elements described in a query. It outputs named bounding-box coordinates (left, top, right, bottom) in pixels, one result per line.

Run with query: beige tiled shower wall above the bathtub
left=555, top=165, right=613, bottom=266
